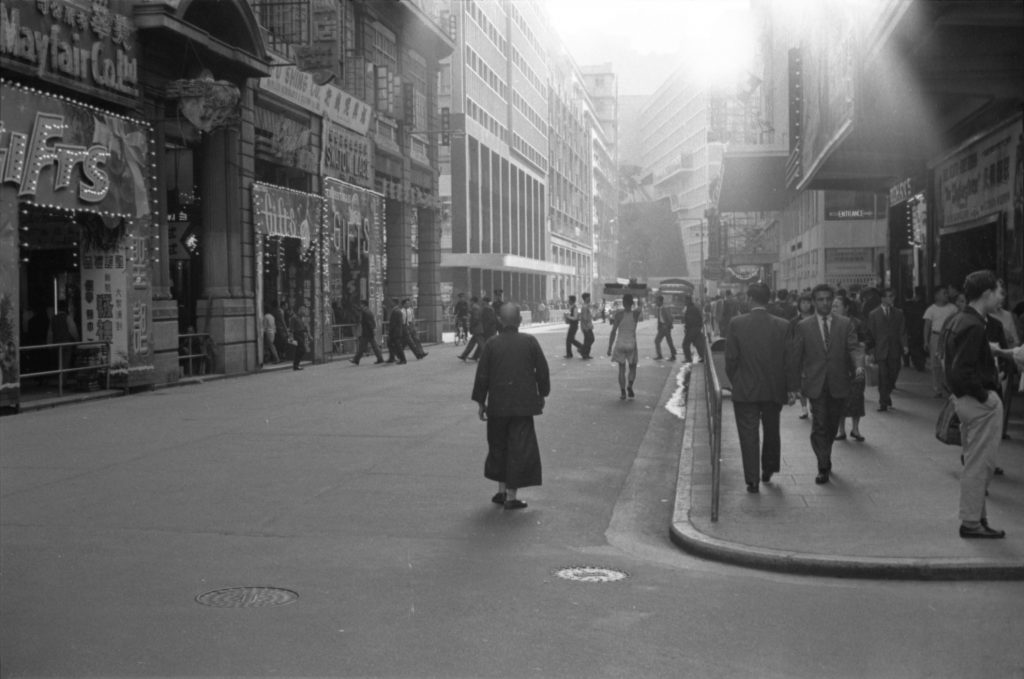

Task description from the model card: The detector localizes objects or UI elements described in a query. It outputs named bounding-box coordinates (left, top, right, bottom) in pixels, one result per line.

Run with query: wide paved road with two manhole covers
left=6, top=323, right=1024, bottom=677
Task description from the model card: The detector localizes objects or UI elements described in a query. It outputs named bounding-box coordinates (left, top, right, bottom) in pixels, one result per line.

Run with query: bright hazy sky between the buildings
left=544, top=0, right=753, bottom=94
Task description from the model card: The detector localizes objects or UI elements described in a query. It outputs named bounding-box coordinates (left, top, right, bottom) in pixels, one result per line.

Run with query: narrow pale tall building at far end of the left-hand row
left=581, top=63, right=618, bottom=299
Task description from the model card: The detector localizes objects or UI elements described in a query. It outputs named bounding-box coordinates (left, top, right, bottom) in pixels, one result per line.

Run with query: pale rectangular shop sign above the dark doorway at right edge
left=935, top=122, right=1021, bottom=227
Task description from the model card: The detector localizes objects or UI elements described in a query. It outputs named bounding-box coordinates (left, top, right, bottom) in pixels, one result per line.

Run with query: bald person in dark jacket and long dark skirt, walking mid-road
left=473, top=303, right=551, bottom=509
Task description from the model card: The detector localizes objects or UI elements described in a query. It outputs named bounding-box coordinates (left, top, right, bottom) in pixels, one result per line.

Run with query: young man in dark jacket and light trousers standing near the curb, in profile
left=943, top=270, right=1007, bottom=538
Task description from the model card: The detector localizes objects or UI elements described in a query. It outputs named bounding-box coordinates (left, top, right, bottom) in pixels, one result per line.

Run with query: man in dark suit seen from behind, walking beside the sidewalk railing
left=725, top=283, right=797, bottom=493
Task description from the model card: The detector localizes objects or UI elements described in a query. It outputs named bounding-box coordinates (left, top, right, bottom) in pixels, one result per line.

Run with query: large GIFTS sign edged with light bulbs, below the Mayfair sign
left=0, top=82, right=151, bottom=217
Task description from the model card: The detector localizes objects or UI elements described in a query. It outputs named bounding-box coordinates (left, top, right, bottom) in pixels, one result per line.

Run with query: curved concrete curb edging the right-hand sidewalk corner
left=670, top=369, right=1024, bottom=581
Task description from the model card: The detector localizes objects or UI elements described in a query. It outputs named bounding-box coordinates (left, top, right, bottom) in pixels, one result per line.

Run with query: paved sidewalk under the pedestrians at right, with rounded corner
left=672, top=362, right=1024, bottom=580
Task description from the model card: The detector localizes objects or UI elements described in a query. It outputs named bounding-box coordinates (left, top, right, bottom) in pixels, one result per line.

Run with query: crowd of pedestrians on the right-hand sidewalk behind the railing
left=720, top=270, right=1024, bottom=539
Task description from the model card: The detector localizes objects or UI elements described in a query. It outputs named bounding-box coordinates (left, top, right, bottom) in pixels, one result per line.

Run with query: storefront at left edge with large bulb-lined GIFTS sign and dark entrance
left=0, top=80, right=154, bottom=406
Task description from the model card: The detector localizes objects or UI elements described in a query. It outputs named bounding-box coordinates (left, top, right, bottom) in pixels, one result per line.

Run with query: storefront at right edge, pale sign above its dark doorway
left=934, top=117, right=1024, bottom=306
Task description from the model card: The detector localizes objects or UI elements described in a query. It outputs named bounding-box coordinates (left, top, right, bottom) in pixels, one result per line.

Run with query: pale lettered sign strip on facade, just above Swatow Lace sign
left=259, top=65, right=373, bottom=134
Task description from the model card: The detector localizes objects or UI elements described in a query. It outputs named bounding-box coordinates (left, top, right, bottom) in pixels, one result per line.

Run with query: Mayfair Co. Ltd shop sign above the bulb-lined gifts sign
left=0, top=0, right=138, bottom=100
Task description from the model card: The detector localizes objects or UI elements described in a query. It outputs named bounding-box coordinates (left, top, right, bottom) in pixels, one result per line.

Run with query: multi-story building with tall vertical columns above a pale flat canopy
left=440, top=0, right=575, bottom=303
